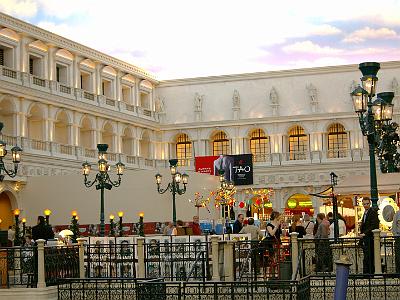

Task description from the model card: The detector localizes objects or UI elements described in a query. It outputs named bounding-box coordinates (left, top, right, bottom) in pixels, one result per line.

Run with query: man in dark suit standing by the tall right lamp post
left=360, top=197, right=379, bottom=274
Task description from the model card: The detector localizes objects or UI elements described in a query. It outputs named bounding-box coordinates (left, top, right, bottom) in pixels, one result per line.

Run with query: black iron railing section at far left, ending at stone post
left=0, top=247, right=37, bottom=288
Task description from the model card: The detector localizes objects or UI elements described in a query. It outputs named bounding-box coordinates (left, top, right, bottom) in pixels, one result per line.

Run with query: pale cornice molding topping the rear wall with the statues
left=157, top=61, right=400, bottom=88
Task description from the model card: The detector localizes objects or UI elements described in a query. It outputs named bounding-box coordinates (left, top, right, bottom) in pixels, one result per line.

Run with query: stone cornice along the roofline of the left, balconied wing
left=0, top=13, right=158, bottom=84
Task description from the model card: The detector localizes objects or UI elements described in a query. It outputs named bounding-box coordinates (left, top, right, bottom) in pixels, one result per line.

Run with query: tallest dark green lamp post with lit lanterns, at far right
left=351, top=62, right=399, bottom=207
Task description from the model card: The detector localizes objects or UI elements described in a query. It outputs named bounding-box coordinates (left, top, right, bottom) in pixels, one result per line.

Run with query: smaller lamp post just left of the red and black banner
left=156, top=159, right=189, bottom=225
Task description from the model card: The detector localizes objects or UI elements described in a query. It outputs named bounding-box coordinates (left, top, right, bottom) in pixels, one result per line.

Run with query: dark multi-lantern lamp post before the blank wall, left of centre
left=82, top=144, right=125, bottom=236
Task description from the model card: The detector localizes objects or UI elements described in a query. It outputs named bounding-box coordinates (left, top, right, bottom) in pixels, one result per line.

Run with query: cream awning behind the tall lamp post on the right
left=334, top=173, right=400, bottom=194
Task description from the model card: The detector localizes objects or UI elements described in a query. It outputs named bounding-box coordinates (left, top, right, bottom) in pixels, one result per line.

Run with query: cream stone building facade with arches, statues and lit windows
left=0, top=14, right=400, bottom=225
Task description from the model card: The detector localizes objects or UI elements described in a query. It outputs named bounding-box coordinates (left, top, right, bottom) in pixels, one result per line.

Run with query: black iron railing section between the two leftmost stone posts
left=44, top=245, right=79, bottom=286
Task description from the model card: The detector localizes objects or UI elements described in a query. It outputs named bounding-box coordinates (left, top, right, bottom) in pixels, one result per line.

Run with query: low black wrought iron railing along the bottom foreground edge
left=58, top=277, right=310, bottom=300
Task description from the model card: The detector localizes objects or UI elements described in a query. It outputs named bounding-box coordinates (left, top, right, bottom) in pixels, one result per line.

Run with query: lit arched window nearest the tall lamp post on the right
left=328, top=123, right=348, bottom=158
